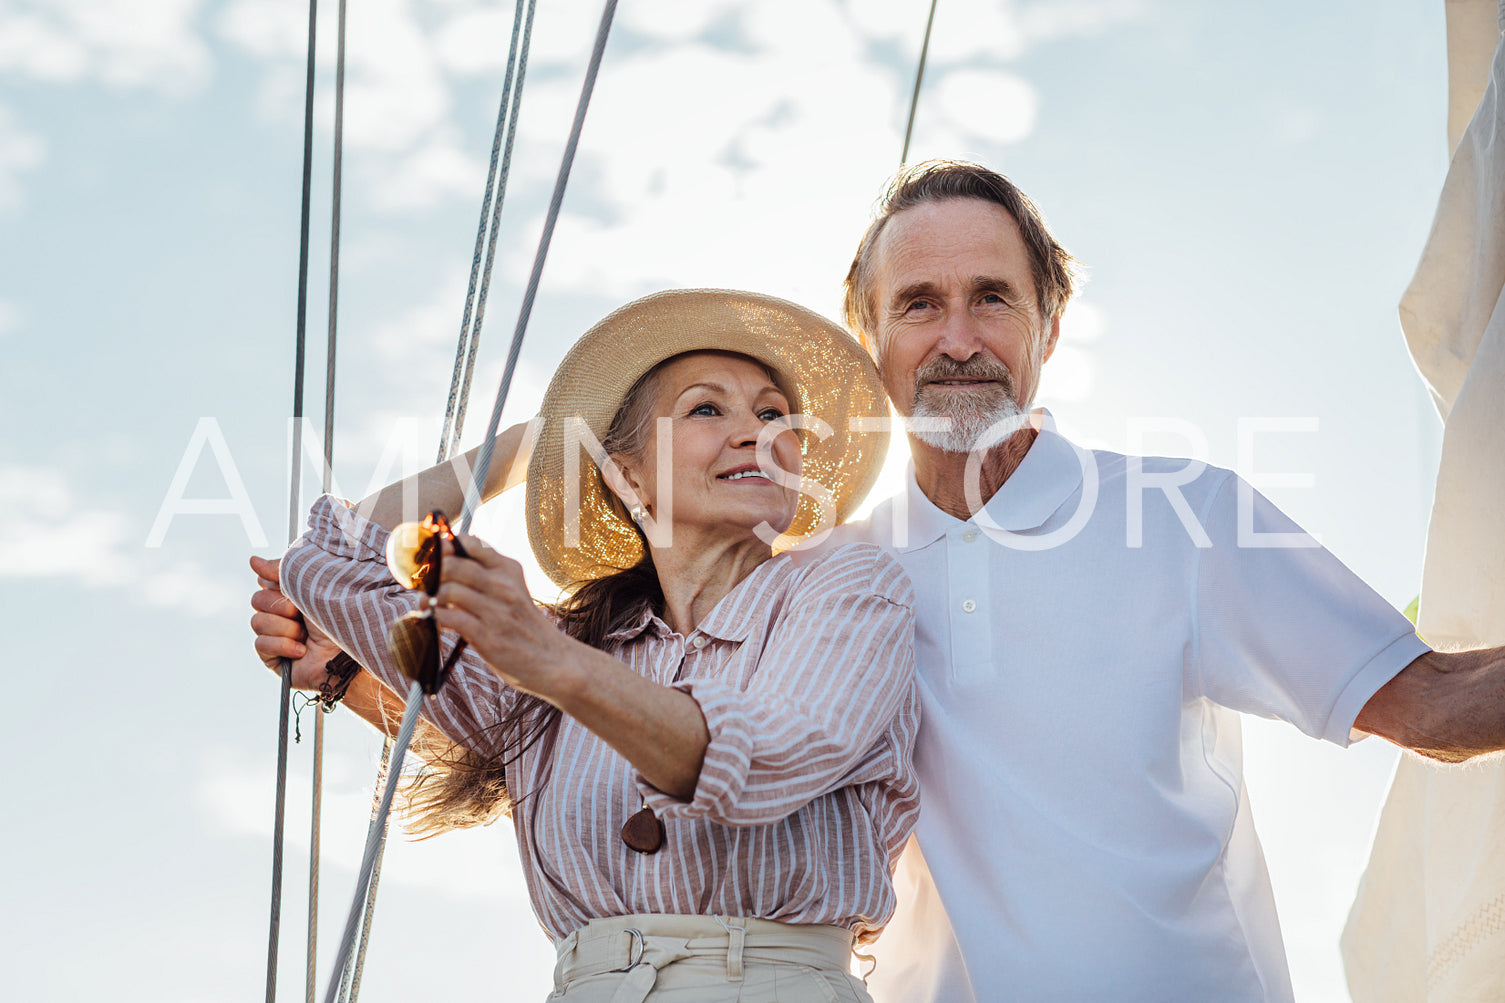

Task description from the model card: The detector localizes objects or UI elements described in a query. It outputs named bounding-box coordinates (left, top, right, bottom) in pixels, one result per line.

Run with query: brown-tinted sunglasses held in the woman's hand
left=387, top=509, right=468, bottom=696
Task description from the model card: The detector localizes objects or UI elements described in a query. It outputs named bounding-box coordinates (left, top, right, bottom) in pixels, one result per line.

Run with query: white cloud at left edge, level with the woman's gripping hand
left=0, top=465, right=245, bottom=616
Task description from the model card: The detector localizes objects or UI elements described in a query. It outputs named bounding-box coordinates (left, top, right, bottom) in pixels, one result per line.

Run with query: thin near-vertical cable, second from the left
left=307, top=0, right=345, bottom=1003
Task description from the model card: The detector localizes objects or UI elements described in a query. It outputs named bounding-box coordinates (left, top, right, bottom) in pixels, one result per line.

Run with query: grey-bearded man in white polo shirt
left=835, top=163, right=1505, bottom=1003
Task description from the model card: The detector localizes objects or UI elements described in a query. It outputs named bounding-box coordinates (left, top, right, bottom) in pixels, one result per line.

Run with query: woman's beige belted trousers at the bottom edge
left=549, top=916, right=871, bottom=1003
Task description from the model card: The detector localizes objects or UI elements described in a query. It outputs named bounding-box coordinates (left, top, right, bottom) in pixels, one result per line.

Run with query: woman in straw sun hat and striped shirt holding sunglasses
left=253, top=291, right=918, bottom=1003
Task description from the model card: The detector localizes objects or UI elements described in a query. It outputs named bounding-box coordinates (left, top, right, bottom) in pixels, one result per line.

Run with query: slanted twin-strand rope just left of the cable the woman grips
left=332, top=0, right=536, bottom=1003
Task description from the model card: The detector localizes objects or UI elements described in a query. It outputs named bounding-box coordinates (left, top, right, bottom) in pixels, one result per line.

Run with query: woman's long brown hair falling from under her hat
left=400, top=358, right=673, bottom=839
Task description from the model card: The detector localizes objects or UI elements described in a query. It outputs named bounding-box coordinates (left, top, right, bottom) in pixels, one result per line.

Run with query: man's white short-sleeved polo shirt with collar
left=832, top=418, right=1428, bottom=1003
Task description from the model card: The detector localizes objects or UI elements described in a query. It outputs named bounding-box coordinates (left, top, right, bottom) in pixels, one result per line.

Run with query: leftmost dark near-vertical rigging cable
left=266, top=0, right=319, bottom=1003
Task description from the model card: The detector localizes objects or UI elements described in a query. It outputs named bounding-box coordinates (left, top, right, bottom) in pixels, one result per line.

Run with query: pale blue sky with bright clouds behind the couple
left=0, top=0, right=1446, bottom=1003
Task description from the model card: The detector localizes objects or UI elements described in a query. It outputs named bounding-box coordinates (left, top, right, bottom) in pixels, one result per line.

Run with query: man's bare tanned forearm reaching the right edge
left=1353, top=648, right=1505, bottom=762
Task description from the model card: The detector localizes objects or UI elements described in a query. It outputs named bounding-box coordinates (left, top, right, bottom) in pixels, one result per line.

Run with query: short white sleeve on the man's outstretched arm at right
left=1193, top=474, right=1430, bottom=745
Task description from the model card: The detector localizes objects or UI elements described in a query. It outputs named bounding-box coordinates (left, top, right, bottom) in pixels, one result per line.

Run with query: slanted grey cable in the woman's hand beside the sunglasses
left=325, top=0, right=617, bottom=1003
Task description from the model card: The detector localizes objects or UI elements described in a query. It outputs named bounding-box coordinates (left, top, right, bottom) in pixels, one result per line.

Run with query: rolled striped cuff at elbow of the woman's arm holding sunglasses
left=637, top=679, right=753, bottom=824
